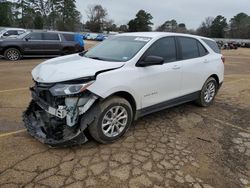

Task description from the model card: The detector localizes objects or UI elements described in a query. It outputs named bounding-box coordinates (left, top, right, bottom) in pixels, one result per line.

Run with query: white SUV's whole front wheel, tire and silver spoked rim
left=88, top=97, right=133, bottom=144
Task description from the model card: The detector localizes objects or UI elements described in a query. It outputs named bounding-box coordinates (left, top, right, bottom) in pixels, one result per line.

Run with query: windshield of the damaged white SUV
left=84, top=36, right=151, bottom=61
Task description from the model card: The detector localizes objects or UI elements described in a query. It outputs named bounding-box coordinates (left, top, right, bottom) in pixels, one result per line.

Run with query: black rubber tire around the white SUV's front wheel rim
left=88, top=96, right=133, bottom=144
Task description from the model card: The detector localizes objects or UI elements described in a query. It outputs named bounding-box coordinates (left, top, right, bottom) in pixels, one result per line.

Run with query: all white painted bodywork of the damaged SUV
left=32, top=32, right=224, bottom=109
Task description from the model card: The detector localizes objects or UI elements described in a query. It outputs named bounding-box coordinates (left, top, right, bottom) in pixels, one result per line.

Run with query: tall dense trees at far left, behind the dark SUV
left=0, top=0, right=82, bottom=31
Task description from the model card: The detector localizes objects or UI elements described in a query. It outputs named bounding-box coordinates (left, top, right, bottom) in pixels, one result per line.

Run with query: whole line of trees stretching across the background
left=0, top=0, right=250, bottom=39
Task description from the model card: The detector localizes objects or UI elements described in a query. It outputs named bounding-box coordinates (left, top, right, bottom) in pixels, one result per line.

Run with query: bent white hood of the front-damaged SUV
left=32, top=54, right=124, bottom=83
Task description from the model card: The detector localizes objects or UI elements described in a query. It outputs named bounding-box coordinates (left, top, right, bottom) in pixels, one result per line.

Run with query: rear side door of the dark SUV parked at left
left=43, top=33, right=61, bottom=55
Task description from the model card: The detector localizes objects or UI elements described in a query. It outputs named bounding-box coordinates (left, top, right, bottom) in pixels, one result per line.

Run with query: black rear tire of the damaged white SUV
left=195, top=77, right=218, bottom=107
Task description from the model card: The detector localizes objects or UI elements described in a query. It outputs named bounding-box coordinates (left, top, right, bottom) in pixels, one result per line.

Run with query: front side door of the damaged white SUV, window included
left=137, top=37, right=182, bottom=108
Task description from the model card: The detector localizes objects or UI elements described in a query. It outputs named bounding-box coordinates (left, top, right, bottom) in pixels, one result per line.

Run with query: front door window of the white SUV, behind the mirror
left=146, top=37, right=176, bottom=62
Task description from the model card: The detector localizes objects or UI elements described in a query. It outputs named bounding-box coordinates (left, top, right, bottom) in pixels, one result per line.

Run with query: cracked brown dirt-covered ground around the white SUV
left=0, top=44, right=250, bottom=188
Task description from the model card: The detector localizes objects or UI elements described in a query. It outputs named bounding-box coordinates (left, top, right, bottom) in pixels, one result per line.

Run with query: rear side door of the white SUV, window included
left=177, top=37, right=210, bottom=96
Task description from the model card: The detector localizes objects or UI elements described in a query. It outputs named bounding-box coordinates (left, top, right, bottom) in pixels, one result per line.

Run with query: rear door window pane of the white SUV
left=178, top=37, right=200, bottom=59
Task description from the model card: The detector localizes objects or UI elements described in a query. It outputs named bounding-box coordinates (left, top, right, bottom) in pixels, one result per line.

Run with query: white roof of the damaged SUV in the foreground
left=118, top=32, right=213, bottom=41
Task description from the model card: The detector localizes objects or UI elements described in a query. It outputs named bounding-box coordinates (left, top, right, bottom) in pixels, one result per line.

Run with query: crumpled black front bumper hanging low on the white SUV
left=23, top=100, right=88, bottom=147
